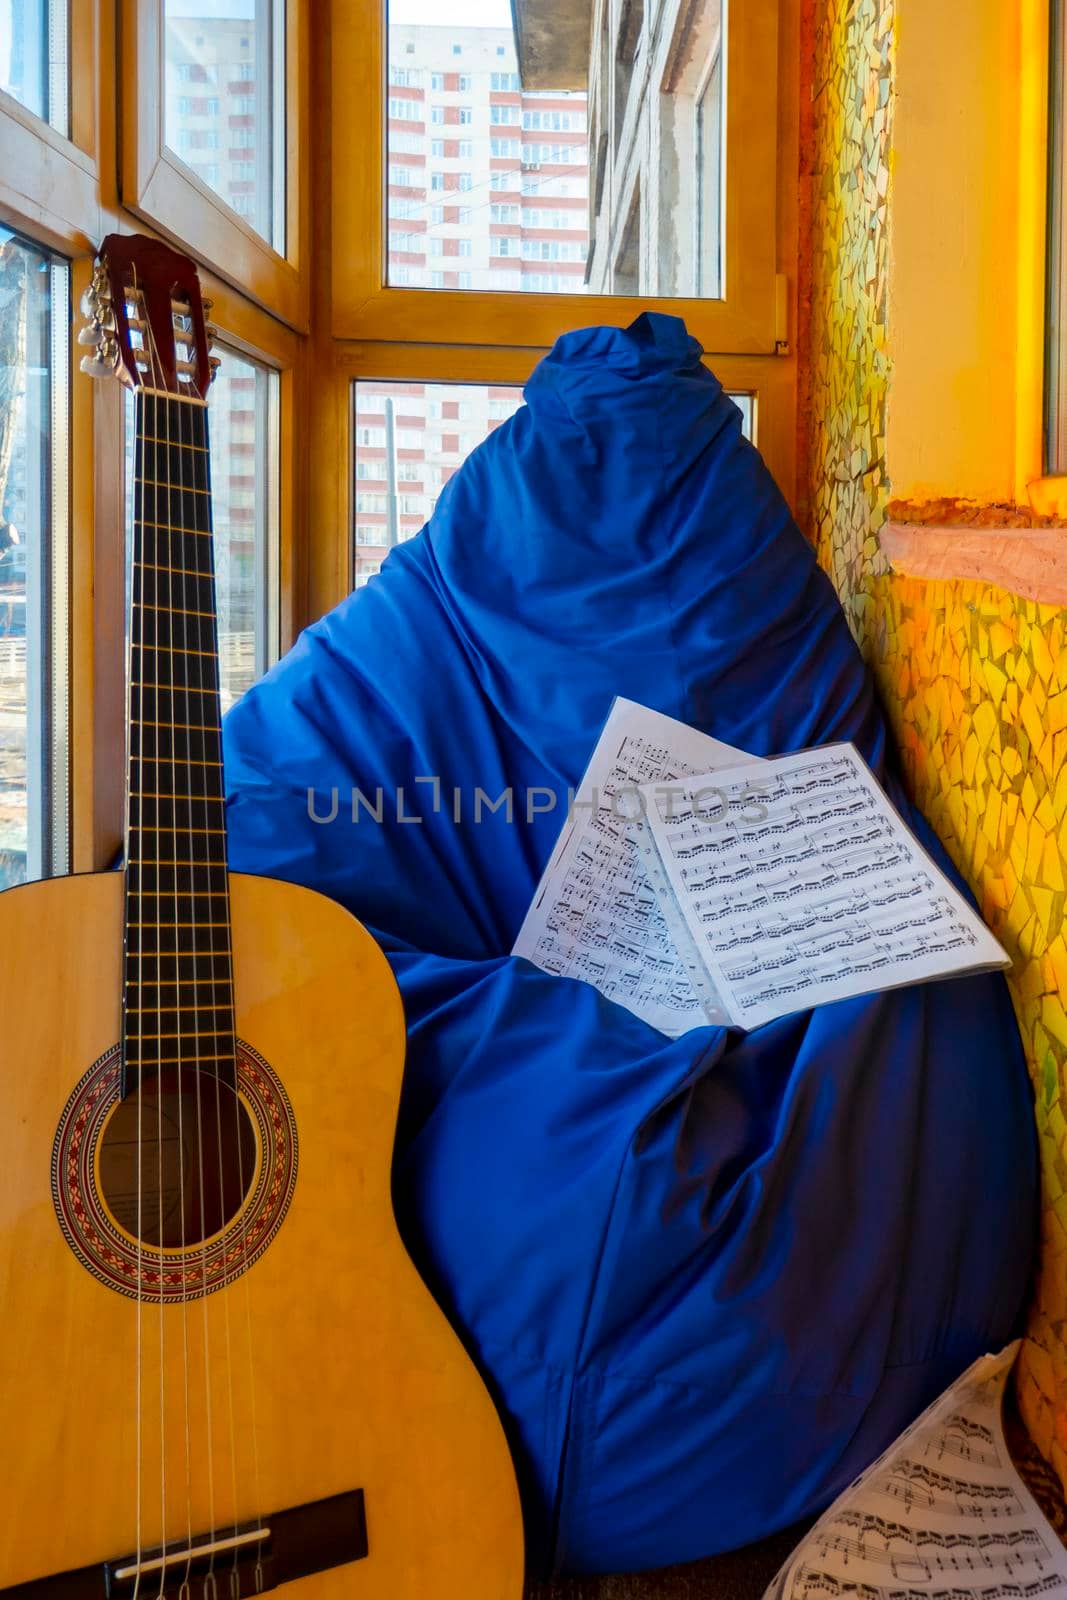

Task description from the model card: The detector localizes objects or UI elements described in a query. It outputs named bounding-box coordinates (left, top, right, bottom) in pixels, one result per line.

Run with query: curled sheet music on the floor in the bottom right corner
left=765, top=1341, right=1067, bottom=1600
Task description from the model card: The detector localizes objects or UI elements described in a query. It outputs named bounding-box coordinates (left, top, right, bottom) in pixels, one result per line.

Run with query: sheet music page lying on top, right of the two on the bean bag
left=641, top=744, right=1009, bottom=1029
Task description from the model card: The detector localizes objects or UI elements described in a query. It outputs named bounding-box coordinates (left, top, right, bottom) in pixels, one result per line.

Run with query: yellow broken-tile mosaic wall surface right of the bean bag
left=800, top=0, right=1067, bottom=1488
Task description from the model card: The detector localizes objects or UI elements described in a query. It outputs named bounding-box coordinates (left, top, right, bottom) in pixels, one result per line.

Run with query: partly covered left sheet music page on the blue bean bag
left=512, top=699, right=753, bottom=1038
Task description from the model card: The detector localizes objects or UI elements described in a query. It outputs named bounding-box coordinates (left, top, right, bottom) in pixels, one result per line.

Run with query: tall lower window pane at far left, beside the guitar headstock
left=0, top=227, right=69, bottom=890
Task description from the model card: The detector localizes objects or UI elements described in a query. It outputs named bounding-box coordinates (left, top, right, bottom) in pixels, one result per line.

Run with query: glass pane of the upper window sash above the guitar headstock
left=165, top=0, right=285, bottom=251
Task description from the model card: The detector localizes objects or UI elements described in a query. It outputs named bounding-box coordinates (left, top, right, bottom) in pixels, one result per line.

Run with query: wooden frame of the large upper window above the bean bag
left=331, top=0, right=787, bottom=355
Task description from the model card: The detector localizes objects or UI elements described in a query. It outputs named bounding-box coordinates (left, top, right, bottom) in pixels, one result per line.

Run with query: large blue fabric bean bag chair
left=226, top=314, right=1035, bottom=1571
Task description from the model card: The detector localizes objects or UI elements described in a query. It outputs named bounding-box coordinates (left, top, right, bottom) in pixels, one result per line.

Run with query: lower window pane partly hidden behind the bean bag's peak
left=352, top=379, right=755, bottom=589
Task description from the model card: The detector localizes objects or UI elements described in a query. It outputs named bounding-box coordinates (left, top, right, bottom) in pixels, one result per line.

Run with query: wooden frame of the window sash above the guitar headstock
left=120, top=0, right=310, bottom=331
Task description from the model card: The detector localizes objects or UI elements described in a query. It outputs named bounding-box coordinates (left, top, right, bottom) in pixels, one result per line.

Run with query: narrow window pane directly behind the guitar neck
left=126, top=346, right=278, bottom=712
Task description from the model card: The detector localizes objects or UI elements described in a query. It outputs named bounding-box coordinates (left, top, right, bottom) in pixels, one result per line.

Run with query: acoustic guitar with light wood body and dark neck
left=0, top=235, right=523, bottom=1600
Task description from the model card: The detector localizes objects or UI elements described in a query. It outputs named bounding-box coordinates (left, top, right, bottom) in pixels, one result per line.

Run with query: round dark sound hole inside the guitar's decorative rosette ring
left=98, top=1067, right=256, bottom=1250
